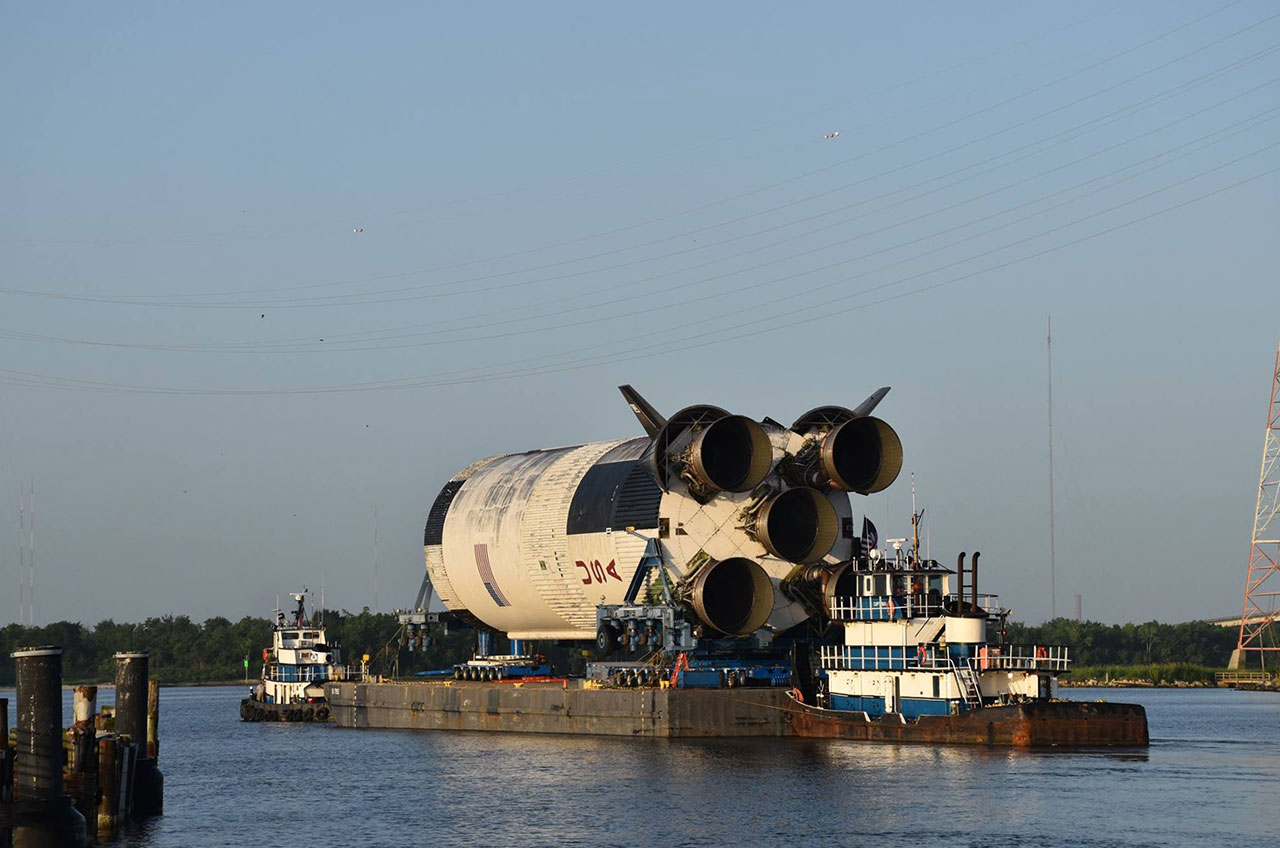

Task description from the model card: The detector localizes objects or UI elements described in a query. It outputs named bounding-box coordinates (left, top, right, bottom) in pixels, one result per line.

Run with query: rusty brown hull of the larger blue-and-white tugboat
left=788, top=698, right=1149, bottom=748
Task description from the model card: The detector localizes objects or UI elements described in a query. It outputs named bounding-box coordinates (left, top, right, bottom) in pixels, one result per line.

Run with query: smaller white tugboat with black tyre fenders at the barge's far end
left=241, top=587, right=346, bottom=721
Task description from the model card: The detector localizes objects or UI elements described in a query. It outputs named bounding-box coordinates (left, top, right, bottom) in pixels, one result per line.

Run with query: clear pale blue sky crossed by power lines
left=0, top=0, right=1280, bottom=625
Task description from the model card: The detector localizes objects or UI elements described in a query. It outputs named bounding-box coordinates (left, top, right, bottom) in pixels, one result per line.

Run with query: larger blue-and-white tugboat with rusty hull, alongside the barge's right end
left=787, top=532, right=1148, bottom=748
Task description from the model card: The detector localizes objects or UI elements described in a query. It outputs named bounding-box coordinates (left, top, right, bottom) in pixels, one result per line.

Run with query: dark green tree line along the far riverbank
left=0, top=607, right=1239, bottom=687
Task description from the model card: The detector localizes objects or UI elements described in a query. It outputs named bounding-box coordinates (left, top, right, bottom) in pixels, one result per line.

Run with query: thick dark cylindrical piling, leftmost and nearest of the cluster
left=9, top=647, right=86, bottom=848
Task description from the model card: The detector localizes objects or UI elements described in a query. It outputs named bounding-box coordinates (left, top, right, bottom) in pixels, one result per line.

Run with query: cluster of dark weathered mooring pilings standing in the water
left=0, top=647, right=164, bottom=848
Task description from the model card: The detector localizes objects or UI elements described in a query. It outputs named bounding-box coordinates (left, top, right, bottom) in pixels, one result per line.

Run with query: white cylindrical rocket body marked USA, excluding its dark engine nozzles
left=424, top=389, right=901, bottom=639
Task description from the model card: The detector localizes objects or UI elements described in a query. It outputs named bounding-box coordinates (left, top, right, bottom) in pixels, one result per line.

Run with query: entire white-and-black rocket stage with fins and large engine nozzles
left=424, top=386, right=902, bottom=640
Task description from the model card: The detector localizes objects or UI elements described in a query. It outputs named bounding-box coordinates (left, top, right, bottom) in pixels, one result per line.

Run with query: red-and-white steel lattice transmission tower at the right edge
left=1231, top=333, right=1280, bottom=669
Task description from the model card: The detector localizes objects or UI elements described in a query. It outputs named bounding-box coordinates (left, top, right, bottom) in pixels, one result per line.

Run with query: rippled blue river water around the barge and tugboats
left=0, top=687, right=1280, bottom=848
